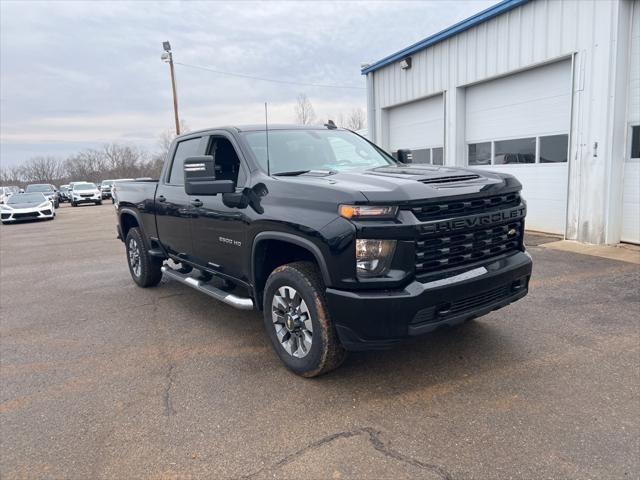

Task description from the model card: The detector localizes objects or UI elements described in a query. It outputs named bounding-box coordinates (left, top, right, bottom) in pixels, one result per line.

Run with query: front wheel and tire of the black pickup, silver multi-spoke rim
left=263, top=262, right=346, bottom=378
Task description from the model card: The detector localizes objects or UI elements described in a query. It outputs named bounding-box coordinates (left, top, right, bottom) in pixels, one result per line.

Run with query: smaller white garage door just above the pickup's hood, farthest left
left=387, top=95, right=444, bottom=165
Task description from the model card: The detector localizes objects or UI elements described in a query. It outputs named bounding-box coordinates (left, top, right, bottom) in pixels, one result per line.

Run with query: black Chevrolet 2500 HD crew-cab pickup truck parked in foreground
left=116, top=123, right=532, bottom=377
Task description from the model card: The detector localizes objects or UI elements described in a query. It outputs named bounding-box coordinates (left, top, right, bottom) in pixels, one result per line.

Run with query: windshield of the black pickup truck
left=243, top=130, right=395, bottom=174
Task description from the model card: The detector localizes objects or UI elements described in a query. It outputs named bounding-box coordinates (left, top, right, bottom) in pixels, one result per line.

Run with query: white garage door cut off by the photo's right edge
left=620, top=2, right=640, bottom=243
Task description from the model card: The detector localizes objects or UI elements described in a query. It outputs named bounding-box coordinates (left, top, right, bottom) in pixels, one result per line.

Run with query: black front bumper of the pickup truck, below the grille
left=326, top=252, right=532, bottom=350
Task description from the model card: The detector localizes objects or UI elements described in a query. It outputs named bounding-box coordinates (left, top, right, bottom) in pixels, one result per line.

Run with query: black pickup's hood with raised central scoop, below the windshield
left=280, top=164, right=521, bottom=204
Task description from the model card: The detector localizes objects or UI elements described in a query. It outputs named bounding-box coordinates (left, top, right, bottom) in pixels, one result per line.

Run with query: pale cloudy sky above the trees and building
left=0, top=0, right=496, bottom=167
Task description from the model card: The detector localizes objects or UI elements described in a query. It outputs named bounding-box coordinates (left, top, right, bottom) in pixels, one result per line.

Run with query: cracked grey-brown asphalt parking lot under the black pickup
left=0, top=203, right=640, bottom=479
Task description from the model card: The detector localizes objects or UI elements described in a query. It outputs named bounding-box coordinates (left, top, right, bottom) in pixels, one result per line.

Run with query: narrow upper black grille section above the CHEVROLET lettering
left=411, top=193, right=521, bottom=222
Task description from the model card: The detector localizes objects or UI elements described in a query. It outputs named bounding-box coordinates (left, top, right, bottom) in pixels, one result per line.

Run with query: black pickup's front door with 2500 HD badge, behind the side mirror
left=192, top=134, right=249, bottom=281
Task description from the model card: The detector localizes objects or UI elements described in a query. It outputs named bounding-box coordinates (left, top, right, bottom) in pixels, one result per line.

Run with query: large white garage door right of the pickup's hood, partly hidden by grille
left=465, top=60, right=571, bottom=234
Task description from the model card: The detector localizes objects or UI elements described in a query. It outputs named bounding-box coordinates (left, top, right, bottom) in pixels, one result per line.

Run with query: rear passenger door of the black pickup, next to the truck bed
left=155, top=136, right=204, bottom=260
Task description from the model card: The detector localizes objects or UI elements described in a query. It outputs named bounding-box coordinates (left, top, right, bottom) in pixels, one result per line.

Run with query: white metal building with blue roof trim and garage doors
left=362, top=0, right=640, bottom=244
